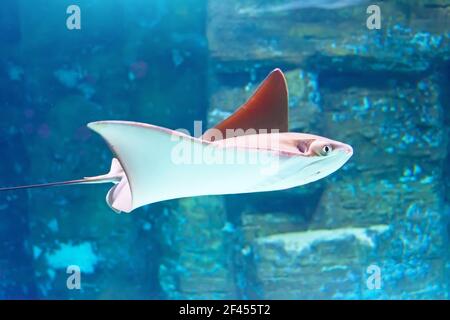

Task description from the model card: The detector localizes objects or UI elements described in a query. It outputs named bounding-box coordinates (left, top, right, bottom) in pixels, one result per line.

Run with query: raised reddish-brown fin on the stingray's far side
left=202, top=69, right=289, bottom=141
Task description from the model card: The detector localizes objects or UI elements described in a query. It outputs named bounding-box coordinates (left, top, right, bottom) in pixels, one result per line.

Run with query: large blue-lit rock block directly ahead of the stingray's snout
left=313, top=75, right=448, bottom=232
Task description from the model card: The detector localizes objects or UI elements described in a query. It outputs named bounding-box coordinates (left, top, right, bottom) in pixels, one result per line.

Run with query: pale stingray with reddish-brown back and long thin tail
left=0, top=69, right=353, bottom=212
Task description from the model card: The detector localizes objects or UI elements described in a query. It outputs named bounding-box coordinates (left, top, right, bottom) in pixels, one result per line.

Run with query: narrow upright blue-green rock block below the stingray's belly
left=157, top=196, right=236, bottom=299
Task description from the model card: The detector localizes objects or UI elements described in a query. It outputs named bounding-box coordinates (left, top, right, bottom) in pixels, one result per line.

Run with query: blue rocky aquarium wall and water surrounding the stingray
left=0, top=0, right=450, bottom=299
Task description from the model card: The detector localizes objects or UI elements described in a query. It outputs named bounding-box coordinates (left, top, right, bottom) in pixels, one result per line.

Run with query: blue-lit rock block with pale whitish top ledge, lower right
left=253, top=225, right=388, bottom=299
